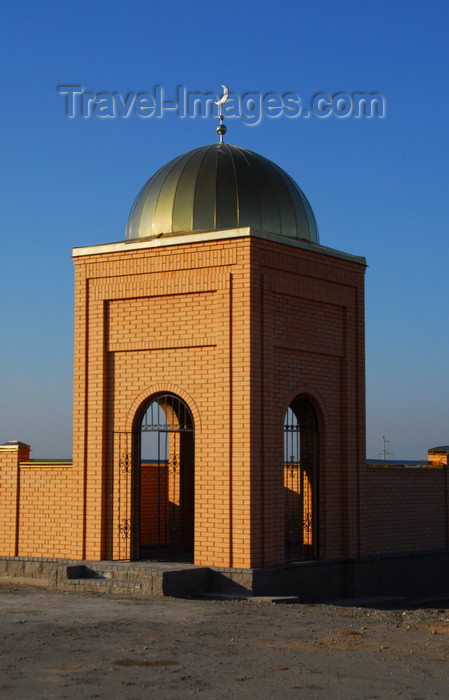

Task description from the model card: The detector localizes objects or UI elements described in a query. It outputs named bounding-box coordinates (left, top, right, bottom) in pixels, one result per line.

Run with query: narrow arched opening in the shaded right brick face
left=284, top=396, right=319, bottom=561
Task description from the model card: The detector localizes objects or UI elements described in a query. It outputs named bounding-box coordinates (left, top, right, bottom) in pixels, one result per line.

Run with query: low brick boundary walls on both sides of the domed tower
left=0, top=443, right=449, bottom=571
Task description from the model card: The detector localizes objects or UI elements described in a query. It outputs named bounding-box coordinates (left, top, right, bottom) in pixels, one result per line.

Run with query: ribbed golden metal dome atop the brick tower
left=125, top=143, right=319, bottom=243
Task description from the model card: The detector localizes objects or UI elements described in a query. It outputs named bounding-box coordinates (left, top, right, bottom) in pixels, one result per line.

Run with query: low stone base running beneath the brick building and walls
left=0, top=550, right=449, bottom=603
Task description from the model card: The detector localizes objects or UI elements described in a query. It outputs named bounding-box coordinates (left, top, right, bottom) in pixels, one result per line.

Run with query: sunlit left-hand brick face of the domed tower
left=74, top=242, right=249, bottom=565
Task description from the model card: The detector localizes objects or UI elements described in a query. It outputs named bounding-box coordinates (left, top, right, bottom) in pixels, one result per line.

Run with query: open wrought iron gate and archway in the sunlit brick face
left=114, top=394, right=194, bottom=561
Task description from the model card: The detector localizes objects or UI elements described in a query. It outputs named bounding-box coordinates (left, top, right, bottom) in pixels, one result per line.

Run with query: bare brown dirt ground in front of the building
left=0, top=580, right=449, bottom=700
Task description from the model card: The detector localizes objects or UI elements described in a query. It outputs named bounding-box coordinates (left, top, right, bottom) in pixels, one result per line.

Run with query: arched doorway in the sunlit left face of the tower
left=133, top=393, right=194, bottom=561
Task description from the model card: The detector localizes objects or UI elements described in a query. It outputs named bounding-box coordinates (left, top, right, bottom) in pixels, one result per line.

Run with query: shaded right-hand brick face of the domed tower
left=252, top=239, right=365, bottom=564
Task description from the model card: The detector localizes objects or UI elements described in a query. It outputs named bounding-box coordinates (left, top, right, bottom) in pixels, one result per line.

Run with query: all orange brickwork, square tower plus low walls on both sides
left=0, top=234, right=449, bottom=568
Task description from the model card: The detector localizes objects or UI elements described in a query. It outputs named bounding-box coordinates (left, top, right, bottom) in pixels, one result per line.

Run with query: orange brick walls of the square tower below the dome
left=68, top=232, right=365, bottom=568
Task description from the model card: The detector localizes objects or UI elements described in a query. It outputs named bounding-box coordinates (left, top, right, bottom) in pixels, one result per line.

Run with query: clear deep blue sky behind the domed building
left=0, top=0, right=449, bottom=459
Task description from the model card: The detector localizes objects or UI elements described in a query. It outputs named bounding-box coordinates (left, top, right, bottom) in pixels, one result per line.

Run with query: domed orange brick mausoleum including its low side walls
left=0, top=143, right=449, bottom=600
